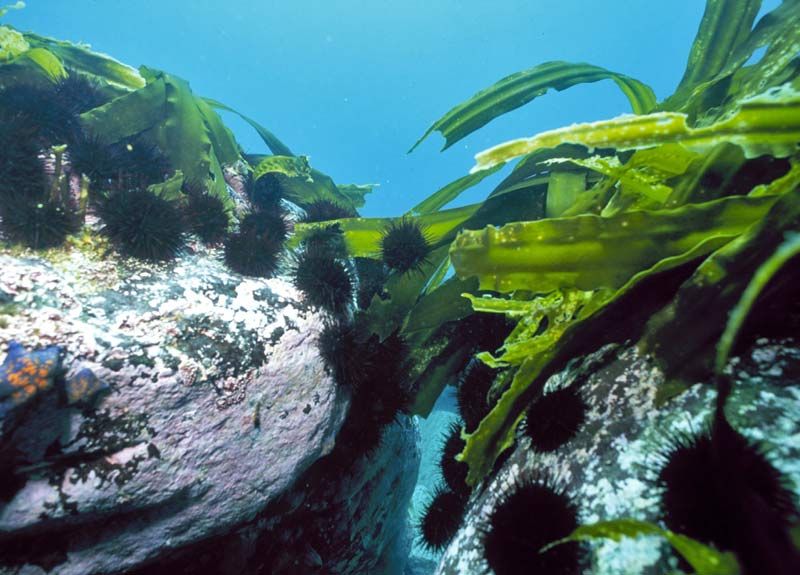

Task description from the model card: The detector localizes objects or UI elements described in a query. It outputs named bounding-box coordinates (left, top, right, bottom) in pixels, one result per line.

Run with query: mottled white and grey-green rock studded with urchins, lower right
left=436, top=339, right=800, bottom=575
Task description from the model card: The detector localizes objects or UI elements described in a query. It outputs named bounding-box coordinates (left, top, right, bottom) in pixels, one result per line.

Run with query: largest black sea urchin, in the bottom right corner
left=659, top=404, right=800, bottom=575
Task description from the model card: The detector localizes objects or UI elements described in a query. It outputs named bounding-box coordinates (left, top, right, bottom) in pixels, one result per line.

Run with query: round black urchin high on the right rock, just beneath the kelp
left=525, top=385, right=586, bottom=452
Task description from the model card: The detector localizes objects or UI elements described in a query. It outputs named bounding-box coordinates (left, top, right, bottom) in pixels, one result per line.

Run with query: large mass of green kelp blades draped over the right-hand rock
left=396, top=0, right=800, bottom=485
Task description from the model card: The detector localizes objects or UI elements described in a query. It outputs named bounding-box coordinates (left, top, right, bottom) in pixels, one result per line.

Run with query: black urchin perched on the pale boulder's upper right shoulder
left=294, top=250, right=353, bottom=314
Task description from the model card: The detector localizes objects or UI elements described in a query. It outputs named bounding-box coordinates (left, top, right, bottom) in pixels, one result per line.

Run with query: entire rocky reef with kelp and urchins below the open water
left=0, top=0, right=800, bottom=575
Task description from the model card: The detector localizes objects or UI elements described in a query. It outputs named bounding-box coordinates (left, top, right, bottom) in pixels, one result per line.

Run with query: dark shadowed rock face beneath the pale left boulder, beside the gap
left=252, top=415, right=420, bottom=575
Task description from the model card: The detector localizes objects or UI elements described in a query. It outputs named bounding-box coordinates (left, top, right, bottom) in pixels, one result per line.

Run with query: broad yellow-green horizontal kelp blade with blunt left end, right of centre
left=450, top=196, right=775, bottom=293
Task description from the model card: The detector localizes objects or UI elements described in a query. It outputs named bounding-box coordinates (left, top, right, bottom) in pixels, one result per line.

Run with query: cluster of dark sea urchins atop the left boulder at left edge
left=0, top=72, right=236, bottom=261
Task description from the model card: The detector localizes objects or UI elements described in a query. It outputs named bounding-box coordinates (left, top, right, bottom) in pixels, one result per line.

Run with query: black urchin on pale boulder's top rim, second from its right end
left=225, top=212, right=287, bottom=277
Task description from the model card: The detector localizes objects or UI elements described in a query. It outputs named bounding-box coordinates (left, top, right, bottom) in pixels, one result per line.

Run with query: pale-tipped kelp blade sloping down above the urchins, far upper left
left=25, top=33, right=145, bottom=92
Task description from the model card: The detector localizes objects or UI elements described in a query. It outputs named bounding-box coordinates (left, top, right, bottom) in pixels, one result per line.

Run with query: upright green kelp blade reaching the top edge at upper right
left=676, top=0, right=761, bottom=103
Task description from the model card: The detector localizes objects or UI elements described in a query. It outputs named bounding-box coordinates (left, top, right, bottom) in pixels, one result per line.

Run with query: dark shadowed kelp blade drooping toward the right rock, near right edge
left=641, top=188, right=800, bottom=390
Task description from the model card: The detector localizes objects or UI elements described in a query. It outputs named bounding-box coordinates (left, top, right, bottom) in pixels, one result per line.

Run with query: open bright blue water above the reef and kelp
left=6, top=0, right=779, bottom=216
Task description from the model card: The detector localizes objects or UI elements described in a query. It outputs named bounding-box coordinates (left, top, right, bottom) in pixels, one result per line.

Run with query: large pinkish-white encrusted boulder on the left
left=0, top=246, right=349, bottom=575
